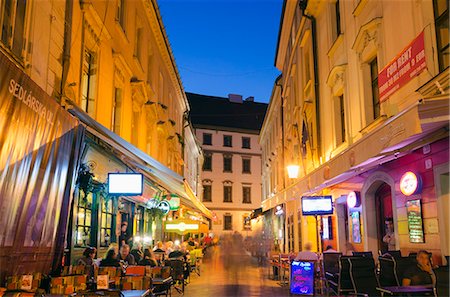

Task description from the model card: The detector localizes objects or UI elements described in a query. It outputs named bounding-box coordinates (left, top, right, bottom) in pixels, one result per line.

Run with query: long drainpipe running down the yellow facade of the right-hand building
left=299, top=0, right=322, bottom=156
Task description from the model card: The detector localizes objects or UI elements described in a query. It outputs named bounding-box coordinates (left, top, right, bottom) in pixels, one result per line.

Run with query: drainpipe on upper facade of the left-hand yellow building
left=60, top=0, right=75, bottom=102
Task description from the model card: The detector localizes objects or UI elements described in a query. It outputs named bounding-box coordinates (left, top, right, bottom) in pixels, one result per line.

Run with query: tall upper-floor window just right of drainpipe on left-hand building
left=81, top=51, right=97, bottom=117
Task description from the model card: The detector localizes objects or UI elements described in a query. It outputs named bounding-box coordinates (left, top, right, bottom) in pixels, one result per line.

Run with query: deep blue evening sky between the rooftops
left=158, top=0, right=283, bottom=102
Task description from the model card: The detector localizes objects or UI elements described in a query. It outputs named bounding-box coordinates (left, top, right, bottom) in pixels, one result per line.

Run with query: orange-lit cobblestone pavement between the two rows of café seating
left=178, top=245, right=289, bottom=297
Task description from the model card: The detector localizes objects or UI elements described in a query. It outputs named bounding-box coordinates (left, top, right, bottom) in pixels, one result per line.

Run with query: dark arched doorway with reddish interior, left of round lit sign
left=375, top=183, right=395, bottom=253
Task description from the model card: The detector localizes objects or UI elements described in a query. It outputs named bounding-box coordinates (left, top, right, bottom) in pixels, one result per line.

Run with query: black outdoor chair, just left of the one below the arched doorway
left=348, top=257, right=381, bottom=296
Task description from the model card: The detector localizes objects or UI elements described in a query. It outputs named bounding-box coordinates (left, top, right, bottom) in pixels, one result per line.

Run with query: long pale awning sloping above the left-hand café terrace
left=66, top=101, right=212, bottom=218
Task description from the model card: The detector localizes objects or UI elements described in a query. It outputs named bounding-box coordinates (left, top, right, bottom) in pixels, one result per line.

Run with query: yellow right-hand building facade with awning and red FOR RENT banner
left=260, top=0, right=449, bottom=263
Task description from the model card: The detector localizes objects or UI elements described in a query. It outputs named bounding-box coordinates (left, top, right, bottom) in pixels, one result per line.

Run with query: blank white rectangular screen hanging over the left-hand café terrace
left=108, top=173, right=144, bottom=196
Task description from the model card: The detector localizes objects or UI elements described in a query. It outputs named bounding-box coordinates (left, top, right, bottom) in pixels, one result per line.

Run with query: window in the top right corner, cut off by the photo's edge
left=433, top=0, right=450, bottom=71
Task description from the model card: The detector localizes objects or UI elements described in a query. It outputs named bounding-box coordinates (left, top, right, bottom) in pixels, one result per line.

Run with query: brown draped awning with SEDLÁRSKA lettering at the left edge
left=0, top=52, right=84, bottom=279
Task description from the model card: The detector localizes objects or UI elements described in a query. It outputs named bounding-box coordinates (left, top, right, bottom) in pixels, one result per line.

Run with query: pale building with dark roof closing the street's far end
left=187, top=93, right=267, bottom=236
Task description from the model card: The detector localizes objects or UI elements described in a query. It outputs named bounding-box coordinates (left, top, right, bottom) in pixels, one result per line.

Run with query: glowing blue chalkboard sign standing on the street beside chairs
left=289, top=261, right=314, bottom=296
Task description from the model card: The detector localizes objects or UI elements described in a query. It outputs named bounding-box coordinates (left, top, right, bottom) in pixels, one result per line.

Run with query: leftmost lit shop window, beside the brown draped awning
left=75, top=192, right=93, bottom=247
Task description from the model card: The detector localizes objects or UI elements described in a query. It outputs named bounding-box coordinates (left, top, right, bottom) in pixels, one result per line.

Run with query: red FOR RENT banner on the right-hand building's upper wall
left=378, top=32, right=427, bottom=102
